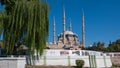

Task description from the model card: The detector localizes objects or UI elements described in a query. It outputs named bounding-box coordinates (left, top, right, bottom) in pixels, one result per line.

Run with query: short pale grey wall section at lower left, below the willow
left=0, top=57, right=26, bottom=68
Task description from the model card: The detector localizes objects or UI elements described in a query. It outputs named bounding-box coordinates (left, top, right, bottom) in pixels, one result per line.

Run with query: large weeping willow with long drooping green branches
left=0, top=0, right=49, bottom=55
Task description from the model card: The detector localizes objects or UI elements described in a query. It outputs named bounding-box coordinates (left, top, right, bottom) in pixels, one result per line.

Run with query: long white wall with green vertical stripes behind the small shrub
left=35, top=55, right=112, bottom=68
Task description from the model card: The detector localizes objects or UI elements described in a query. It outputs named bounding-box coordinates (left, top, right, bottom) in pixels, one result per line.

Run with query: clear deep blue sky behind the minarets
left=0, top=0, right=120, bottom=46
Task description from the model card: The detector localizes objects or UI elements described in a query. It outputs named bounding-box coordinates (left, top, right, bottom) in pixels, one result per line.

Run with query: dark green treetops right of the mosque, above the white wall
left=84, top=39, right=120, bottom=52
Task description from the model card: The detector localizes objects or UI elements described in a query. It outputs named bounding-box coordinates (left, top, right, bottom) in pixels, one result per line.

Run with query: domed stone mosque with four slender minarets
left=47, top=9, right=85, bottom=50
